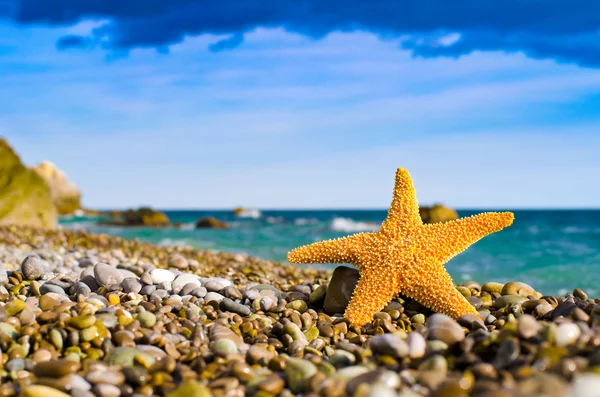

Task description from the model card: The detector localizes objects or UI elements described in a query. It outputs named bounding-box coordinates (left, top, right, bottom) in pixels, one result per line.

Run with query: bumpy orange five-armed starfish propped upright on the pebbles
left=287, top=168, right=514, bottom=326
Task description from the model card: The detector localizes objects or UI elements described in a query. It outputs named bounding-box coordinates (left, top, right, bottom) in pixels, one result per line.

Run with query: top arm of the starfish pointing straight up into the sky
left=381, top=168, right=423, bottom=235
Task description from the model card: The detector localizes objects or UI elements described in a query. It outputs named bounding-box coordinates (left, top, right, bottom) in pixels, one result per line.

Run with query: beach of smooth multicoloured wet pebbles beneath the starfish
left=0, top=226, right=600, bottom=397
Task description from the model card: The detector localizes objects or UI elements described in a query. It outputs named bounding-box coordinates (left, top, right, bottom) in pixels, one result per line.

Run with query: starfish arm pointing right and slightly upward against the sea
left=420, top=212, right=514, bottom=263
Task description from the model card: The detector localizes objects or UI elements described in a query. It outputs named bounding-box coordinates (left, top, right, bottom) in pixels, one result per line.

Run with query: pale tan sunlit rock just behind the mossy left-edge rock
left=34, top=161, right=81, bottom=215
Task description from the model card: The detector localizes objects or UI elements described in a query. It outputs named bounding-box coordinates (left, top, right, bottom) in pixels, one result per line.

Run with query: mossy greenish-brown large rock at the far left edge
left=0, top=138, right=57, bottom=228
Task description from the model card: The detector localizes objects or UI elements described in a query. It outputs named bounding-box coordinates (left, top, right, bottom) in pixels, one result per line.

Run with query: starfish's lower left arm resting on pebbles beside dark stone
left=344, top=268, right=398, bottom=326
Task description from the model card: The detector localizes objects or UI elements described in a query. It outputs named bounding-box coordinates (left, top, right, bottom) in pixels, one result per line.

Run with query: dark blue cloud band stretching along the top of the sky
left=0, top=0, right=600, bottom=67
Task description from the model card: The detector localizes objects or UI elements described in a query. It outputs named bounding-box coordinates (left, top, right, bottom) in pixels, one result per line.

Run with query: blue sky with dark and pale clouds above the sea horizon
left=0, top=0, right=600, bottom=209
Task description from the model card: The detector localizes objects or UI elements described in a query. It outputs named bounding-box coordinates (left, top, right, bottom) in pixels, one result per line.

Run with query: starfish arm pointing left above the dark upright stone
left=287, top=233, right=376, bottom=266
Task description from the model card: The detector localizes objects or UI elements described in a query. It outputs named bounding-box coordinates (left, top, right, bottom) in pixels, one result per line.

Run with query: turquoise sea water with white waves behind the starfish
left=62, top=210, right=600, bottom=296
